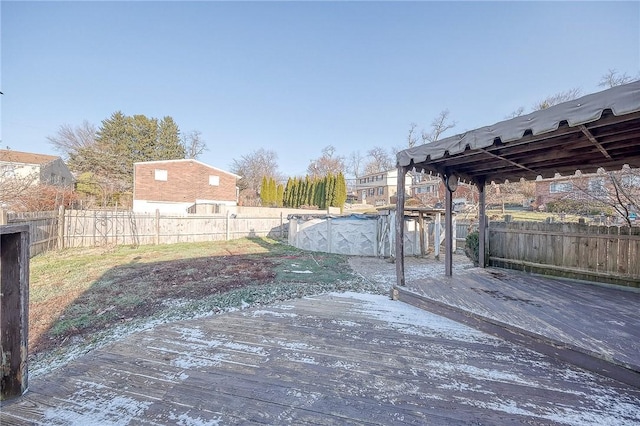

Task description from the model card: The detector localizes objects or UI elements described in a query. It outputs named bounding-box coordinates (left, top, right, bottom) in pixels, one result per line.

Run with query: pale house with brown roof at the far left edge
left=0, top=149, right=75, bottom=187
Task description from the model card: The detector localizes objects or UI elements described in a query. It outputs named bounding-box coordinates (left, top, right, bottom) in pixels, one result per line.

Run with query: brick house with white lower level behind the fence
left=133, top=159, right=240, bottom=213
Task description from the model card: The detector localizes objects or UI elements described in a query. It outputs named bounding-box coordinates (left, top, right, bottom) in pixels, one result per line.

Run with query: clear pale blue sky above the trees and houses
left=0, top=1, right=640, bottom=176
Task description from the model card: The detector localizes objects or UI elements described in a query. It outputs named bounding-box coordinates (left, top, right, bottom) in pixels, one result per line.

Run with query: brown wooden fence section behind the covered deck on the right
left=489, top=222, right=640, bottom=287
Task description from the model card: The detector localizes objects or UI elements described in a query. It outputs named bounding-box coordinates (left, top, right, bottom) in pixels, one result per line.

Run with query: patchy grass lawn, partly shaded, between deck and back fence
left=29, top=238, right=380, bottom=372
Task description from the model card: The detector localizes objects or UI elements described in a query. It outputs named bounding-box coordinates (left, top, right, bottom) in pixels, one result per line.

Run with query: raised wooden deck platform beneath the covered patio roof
left=399, top=268, right=640, bottom=388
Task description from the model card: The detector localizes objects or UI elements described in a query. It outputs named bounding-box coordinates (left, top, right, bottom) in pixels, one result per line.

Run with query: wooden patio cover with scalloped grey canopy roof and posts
left=396, top=81, right=640, bottom=286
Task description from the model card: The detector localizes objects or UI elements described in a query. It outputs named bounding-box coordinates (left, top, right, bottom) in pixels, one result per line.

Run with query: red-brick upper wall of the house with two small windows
left=134, top=160, right=236, bottom=203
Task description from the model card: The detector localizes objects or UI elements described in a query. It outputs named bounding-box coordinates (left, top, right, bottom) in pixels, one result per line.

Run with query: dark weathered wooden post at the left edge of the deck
left=0, top=225, right=29, bottom=401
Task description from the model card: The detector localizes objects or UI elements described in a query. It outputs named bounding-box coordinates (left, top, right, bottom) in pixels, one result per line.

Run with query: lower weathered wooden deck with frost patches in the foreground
left=0, top=292, right=640, bottom=426
